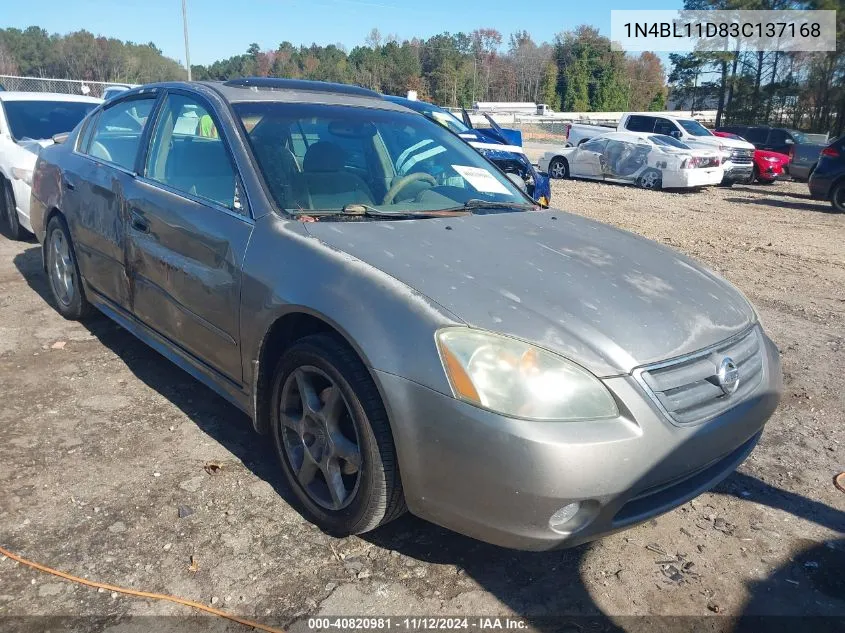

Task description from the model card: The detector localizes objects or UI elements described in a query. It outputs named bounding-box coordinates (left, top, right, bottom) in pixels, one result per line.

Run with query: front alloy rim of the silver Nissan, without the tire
left=279, top=366, right=363, bottom=510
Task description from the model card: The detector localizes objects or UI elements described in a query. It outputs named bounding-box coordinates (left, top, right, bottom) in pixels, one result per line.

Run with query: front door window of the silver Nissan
left=144, top=94, right=235, bottom=209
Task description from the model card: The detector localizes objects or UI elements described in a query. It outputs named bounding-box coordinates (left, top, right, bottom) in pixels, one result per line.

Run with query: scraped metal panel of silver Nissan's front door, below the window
left=128, top=182, right=252, bottom=381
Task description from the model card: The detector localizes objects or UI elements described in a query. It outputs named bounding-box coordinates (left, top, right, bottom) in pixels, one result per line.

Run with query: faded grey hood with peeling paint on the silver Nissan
left=305, top=211, right=755, bottom=376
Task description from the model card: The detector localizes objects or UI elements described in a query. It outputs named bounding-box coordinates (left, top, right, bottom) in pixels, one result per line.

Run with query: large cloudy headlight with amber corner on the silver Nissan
left=435, top=327, right=619, bottom=420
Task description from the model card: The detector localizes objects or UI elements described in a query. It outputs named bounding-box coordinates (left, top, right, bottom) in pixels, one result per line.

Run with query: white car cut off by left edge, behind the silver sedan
left=0, top=91, right=102, bottom=239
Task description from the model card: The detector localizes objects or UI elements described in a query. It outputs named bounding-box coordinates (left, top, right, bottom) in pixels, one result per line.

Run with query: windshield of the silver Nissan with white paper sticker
left=233, top=102, right=533, bottom=215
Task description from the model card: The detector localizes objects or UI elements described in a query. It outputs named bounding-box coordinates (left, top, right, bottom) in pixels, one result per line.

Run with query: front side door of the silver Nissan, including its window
left=127, top=91, right=254, bottom=383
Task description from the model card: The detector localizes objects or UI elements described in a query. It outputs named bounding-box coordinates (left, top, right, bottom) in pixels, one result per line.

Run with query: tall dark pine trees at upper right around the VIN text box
left=669, top=0, right=845, bottom=136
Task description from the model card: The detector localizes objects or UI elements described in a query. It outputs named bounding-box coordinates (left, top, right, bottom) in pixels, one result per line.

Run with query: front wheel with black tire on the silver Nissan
left=270, top=334, right=406, bottom=536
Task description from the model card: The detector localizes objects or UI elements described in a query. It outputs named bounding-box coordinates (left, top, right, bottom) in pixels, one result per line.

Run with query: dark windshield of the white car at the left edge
left=3, top=100, right=97, bottom=141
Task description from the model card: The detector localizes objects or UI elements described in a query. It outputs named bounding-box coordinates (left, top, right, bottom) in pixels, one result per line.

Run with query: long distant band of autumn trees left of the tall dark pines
left=0, top=26, right=667, bottom=111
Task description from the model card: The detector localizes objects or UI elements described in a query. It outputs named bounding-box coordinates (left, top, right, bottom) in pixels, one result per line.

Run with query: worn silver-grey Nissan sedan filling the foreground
left=31, top=78, right=781, bottom=550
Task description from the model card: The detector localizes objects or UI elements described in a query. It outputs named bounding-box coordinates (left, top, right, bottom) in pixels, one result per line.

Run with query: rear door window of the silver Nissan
left=85, top=97, right=155, bottom=171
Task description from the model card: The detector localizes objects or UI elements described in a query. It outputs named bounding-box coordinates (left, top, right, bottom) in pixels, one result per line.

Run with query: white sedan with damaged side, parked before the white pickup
left=539, top=132, right=724, bottom=189
